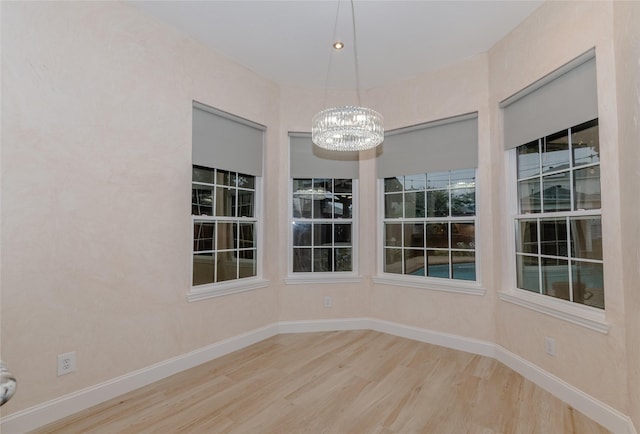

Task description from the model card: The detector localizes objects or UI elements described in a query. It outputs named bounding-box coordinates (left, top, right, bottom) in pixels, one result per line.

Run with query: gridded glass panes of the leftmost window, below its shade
left=191, top=166, right=257, bottom=286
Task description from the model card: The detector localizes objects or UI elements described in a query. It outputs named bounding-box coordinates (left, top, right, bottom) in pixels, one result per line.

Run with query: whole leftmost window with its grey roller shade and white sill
left=192, top=102, right=268, bottom=301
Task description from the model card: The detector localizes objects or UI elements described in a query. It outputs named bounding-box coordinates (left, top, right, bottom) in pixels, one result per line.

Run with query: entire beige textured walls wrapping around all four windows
left=1, top=2, right=640, bottom=425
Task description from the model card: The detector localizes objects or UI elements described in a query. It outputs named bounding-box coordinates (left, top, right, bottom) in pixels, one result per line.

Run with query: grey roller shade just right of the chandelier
left=377, top=113, right=478, bottom=178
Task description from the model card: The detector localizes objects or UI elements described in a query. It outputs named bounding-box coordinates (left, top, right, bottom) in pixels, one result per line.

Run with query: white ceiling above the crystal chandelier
left=130, top=0, right=542, bottom=90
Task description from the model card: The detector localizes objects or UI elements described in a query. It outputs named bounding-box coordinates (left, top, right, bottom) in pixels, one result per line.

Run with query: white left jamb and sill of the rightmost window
left=498, top=148, right=611, bottom=334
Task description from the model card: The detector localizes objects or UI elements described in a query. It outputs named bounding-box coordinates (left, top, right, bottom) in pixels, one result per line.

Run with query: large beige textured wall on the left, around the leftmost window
left=2, top=2, right=279, bottom=414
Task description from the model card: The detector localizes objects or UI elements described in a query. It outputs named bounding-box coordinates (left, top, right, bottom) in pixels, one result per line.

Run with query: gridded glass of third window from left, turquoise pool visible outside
left=383, top=169, right=476, bottom=281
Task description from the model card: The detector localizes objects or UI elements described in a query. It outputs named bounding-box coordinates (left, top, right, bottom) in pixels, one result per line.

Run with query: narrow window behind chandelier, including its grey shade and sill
left=286, top=132, right=360, bottom=284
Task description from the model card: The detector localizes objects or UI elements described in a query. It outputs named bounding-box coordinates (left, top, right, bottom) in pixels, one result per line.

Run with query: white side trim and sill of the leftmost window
left=187, top=173, right=270, bottom=302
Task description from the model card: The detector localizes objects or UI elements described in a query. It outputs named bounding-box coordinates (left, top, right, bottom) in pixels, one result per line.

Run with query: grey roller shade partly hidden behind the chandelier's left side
left=289, top=133, right=358, bottom=179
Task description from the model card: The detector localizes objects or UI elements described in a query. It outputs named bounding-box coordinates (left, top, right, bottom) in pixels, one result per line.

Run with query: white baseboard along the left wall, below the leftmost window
left=0, top=324, right=278, bottom=434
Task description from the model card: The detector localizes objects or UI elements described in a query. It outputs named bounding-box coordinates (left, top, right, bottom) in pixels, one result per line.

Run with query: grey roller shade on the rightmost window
left=500, top=50, right=598, bottom=149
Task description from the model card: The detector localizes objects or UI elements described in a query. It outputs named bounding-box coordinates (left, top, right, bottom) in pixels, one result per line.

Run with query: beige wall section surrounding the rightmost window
left=489, top=2, right=628, bottom=412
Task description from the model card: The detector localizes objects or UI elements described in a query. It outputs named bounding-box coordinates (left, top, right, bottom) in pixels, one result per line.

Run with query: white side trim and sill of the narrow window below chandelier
left=284, top=177, right=362, bottom=285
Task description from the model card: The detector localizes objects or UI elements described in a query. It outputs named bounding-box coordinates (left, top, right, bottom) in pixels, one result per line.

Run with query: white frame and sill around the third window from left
left=373, top=176, right=487, bottom=296
